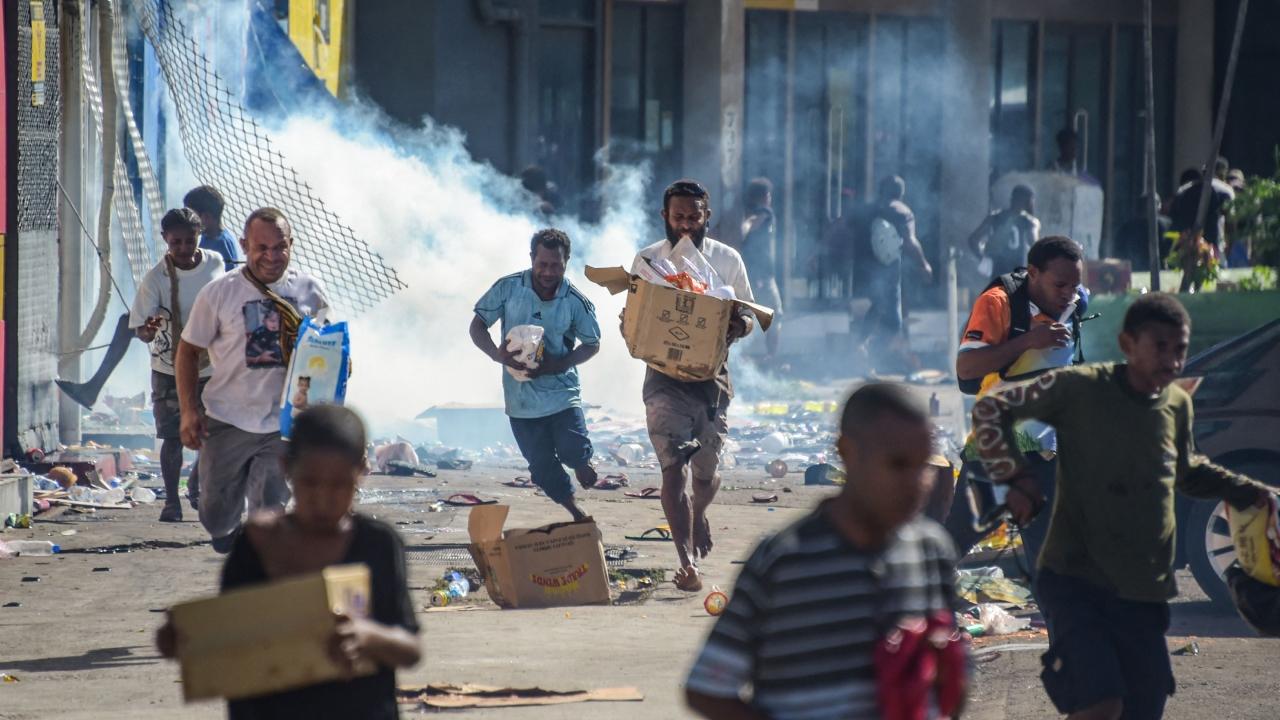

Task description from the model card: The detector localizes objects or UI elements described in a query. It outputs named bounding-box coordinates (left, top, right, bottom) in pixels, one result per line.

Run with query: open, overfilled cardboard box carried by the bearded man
left=586, top=266, right=773, bottom=382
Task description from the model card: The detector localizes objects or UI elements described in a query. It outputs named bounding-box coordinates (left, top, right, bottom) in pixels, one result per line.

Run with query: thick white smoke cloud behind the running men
left=271, top=112, right=646, bottom=432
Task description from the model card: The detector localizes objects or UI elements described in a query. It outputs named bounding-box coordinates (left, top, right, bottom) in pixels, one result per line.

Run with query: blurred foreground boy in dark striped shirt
left=686, top=383, right=955, bottom=720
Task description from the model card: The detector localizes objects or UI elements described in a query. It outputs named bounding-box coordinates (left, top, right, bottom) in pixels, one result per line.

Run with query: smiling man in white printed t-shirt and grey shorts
left=177, top=208, right=329, bottom=552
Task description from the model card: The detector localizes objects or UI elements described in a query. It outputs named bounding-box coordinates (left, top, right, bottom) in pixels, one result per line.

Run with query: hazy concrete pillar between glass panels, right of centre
left=941, top=0, right=992, bottom=247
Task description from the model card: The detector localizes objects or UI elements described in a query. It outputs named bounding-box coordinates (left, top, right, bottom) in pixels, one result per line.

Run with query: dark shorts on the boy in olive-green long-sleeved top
left=1036, top=568, right=1174, bottom=720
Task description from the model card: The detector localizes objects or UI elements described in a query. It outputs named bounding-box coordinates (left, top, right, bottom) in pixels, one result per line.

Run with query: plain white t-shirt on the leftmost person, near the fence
left=129, top=250, right=225, bottom=378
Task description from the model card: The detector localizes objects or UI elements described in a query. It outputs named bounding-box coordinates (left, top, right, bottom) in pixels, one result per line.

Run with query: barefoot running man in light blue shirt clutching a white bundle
left=471, top=229, right=600, bottom=520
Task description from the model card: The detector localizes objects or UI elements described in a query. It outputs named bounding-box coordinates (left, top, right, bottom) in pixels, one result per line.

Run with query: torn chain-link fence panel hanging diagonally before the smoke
left=133, top=0, right=404, bottom=313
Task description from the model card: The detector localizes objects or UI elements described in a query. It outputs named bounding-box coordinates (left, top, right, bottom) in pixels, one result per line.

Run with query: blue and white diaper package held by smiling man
left=280, top=318, right=351, bottom=439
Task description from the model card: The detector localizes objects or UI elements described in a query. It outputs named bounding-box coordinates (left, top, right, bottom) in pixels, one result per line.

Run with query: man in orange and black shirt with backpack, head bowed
left=947, top=236, right=1087, bottom=576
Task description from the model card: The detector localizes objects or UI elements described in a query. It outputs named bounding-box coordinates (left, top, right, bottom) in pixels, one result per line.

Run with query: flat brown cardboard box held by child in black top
left=169, top=564, right=375, bottom=702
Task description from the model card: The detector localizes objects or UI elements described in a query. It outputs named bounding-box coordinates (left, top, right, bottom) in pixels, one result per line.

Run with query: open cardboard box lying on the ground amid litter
left=467, top=505, right=609, bottom=607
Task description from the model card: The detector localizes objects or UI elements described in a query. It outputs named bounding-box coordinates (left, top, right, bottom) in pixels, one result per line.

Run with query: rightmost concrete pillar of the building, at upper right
left=1172, top=0, right=1213, bottom=182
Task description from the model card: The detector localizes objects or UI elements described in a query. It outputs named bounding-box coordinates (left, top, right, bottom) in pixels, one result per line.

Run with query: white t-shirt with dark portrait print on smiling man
left=182, top=269, right=329, bottom=434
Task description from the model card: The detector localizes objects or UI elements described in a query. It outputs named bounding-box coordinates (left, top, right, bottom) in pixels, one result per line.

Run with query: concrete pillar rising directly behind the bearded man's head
left=686, top=0, right=746, bottom=242
